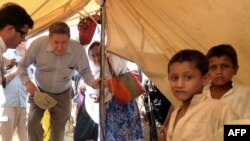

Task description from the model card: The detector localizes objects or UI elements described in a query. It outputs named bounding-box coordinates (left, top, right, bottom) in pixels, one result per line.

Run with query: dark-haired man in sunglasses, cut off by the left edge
left=0, top=3, right=34, bottom=141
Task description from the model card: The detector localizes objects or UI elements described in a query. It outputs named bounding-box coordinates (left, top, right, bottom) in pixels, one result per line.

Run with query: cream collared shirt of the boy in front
left=167, top=94, right=237, bottom=141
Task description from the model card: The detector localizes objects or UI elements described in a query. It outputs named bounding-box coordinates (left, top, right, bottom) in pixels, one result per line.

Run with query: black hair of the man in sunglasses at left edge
left=0, top=2, right=34, bottom=29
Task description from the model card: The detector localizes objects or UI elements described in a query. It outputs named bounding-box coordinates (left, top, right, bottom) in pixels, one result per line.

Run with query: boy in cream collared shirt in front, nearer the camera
left=166, top=49, right=237, bottom=141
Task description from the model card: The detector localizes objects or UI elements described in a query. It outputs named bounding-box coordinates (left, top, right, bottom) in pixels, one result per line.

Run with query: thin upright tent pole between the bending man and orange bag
left=99, top=0, right=106, bottom=141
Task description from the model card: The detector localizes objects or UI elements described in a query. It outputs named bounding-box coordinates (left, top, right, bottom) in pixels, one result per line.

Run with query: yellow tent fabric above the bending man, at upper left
left=0, top=0, right=90, bottom=37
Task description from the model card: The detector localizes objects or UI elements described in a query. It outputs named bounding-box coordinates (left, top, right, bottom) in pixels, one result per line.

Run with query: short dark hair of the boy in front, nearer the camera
left=168, top=49, right=208, bottom=76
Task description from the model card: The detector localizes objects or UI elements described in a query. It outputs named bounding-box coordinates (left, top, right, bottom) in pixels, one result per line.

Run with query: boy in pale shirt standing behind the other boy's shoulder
left=205, top=44, right=250, bottom=119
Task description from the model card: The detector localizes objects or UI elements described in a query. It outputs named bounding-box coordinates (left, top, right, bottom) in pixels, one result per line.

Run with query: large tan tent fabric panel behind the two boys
left=106, top=0, right=250, bottom=105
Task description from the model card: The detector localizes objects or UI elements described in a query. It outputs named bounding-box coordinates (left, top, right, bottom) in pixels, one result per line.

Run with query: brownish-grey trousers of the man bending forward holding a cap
left=28, top=88, right=73, bottom=141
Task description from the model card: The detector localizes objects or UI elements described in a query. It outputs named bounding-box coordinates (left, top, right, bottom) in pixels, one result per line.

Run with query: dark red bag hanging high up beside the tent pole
left=77, top=15, right=100, bottom=45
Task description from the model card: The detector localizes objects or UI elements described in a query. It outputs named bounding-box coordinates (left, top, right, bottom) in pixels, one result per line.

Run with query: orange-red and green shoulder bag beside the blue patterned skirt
left=107, top=72, right=145, bottom=104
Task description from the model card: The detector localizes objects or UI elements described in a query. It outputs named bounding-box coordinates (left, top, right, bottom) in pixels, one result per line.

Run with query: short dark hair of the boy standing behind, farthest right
left=206, top=44, right=238, bottom=67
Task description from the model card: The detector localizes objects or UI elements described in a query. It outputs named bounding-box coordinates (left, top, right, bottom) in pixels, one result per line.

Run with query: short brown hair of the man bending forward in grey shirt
left=49, top=22, right=70, bottom=38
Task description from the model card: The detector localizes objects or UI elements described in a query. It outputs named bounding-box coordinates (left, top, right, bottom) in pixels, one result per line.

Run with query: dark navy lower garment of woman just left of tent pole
left=74, top=101, right=98, bottom=141
